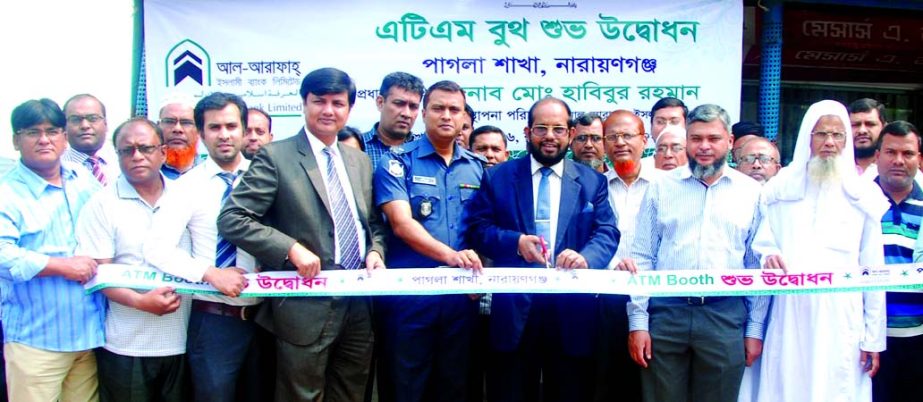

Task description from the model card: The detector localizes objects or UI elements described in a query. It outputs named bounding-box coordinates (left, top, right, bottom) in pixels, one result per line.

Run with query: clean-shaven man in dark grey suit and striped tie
left=218, top=68, right=385, bottom=401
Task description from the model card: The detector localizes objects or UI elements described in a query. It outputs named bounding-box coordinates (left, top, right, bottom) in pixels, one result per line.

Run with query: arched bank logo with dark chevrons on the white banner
left=164, top=39, right=212, bottom=87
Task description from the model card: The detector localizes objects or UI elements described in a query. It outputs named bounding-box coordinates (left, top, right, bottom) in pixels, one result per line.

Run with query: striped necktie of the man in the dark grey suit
left=324, top=147, right=362, bottom=269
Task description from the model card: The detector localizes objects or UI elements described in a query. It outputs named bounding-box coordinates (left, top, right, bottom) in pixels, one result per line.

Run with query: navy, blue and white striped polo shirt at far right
left=875, top=177, right=923, bottom=337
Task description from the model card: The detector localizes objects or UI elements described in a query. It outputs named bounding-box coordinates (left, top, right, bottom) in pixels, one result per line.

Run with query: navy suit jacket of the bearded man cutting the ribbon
left=467, top=156, right=619, bottom=356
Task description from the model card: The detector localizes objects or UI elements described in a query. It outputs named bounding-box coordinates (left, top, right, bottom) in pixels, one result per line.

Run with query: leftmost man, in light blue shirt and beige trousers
left=0, top=99, right=106, bottom=401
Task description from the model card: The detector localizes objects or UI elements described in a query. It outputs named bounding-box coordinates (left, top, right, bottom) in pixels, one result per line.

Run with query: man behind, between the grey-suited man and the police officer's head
left=362, top=71, right=424, bottom=170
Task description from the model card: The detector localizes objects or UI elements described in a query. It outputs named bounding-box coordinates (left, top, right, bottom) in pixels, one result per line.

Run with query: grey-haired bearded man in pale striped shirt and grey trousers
left=619, top=104, right=769, bottom=402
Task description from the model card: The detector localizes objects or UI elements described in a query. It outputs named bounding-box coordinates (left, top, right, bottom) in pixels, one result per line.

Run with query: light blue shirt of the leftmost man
left=0, top=162, right=106, bottom=352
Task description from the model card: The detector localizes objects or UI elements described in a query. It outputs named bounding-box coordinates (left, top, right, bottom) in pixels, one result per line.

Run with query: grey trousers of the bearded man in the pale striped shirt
left=641, top=297, right=747, bottom=402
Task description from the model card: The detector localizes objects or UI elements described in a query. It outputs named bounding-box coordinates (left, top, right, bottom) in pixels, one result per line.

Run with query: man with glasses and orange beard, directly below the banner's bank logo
left=158, top=96, right=205, bottom=180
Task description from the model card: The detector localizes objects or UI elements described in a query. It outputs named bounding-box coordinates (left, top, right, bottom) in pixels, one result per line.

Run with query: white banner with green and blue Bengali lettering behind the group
left=144, top=0, right=743, bottom=150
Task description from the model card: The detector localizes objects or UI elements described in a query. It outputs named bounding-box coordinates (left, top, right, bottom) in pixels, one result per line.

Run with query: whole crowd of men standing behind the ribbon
left=0, top=68, right=923, bottom=402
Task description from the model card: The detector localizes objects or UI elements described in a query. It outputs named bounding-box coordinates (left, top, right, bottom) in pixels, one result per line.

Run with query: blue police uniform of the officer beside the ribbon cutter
left=374, top=136, right=485, bottom=402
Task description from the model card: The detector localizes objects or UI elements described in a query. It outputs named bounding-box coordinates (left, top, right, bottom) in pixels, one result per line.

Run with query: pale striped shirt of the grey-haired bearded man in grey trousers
left=628, top=166, right=769, bottom=339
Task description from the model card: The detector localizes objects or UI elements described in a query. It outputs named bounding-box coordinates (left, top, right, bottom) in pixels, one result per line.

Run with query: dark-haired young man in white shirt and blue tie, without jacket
left=143, top=92, right=260, bottom=401
